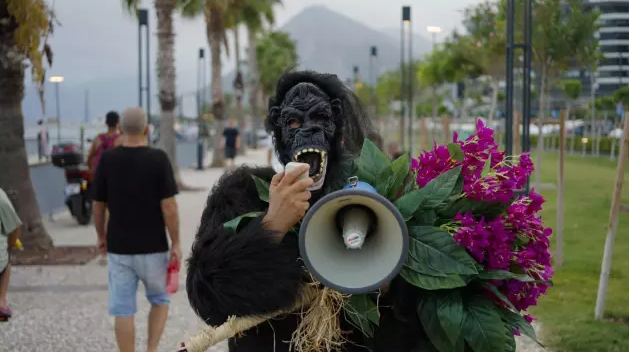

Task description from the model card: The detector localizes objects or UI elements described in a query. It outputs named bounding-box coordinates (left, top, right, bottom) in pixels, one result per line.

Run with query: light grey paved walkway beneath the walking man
left=0, top=151, right=538, bottom=352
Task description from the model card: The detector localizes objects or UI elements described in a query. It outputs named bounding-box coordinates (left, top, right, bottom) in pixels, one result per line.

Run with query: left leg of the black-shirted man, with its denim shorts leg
left=108, top=253, right=138, bottom=352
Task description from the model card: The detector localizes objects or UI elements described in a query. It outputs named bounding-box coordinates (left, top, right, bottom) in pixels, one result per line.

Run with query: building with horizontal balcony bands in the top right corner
left=585, top=0, right=629, bottom=96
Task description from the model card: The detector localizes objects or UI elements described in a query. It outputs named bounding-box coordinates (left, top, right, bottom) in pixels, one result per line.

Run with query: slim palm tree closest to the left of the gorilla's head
left=239, top=0, right=282, bottom=149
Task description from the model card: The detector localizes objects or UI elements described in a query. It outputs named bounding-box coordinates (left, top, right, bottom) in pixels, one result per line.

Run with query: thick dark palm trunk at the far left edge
left=0, top=23, right=53, bottom=249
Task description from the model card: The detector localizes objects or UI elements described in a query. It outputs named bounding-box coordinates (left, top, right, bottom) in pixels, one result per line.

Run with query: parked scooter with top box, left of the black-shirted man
left=51, top=143, right=92, bottom=225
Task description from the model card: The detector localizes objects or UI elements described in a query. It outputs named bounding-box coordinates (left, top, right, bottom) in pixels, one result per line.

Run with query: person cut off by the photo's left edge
left=0, top=188, right=22, bottom=321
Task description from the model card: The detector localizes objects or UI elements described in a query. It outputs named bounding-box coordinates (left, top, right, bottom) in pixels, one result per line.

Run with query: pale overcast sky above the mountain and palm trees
left=43, top=0, right=480, bottom=84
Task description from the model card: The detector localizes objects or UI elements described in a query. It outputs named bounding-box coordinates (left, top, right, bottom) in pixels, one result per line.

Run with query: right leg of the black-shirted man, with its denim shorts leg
left=138, top=252, right=170, bottom=352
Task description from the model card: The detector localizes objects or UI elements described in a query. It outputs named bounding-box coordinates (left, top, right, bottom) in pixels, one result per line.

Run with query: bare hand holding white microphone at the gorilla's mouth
left=263, top=165, right=314, bottom=234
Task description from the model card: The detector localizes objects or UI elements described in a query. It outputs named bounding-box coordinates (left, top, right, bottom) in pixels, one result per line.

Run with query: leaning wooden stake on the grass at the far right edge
left=594, top=111, right=629, bottom=319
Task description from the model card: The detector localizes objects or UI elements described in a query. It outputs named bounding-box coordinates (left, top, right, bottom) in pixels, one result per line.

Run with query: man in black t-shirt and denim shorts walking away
left=93, top=108, right=181, bottom=352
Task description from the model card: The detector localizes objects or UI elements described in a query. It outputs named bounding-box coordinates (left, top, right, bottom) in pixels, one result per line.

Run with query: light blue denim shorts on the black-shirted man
left=107, top=252, right=170, bottom=317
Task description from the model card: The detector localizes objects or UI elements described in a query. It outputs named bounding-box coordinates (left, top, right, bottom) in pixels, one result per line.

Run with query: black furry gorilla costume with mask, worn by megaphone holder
left=186, top=71, right=424, bottom=352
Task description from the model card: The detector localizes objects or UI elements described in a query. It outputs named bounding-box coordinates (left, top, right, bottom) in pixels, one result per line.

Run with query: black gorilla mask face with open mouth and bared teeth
left=269, top=82, right=342, bottom=191
